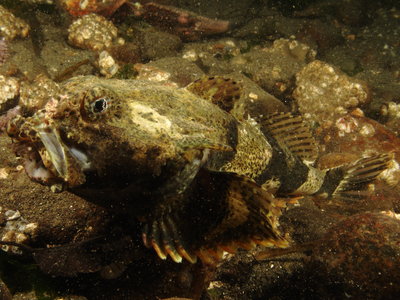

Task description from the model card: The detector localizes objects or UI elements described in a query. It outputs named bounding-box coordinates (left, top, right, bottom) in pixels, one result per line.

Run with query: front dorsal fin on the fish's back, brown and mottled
left=186, top=76, right=242, bottom=112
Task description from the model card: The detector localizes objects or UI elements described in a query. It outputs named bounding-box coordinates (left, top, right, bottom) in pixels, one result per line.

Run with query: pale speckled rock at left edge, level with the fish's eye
left=0, top=75, right=20, bottom=114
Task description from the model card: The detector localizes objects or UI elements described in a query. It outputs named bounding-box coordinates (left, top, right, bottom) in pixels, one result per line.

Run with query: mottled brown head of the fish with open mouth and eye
left=7, top=77, right=181, bottom=188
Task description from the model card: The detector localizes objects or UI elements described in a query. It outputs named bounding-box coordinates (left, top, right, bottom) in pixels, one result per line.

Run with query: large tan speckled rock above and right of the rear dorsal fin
left=293, top=60, right=370, bottom=122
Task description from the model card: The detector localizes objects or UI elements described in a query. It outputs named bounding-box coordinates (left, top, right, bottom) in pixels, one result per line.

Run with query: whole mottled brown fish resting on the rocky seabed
left=7, top=76, right=392, bottom=265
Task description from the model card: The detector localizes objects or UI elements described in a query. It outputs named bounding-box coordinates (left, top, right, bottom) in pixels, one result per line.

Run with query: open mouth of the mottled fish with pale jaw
left=15, top=124, right=91, bottom=188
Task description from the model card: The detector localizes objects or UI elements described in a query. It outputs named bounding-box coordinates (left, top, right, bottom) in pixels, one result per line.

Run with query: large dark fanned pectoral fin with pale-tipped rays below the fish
left=143, top=170, right=288, bottom=264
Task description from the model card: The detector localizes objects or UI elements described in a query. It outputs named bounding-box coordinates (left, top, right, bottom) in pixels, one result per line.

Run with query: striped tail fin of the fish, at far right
left=316, top=153, right=393, bottom=201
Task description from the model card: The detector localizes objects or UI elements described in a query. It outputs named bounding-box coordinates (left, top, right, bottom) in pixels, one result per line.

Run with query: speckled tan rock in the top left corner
left=0, top=5, right=30, bottom=40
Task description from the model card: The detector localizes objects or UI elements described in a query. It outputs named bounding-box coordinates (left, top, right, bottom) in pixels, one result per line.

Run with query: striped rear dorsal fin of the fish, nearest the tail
left=260, top=112, right=318, bottom=162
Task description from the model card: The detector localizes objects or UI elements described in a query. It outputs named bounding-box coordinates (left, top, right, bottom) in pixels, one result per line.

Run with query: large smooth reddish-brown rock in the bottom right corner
left=314, top=213, right=400, bottom=299
